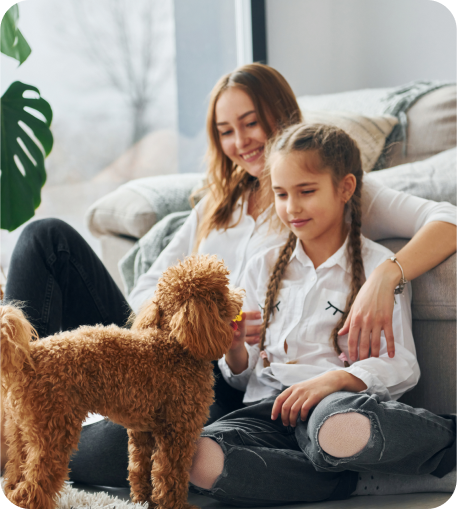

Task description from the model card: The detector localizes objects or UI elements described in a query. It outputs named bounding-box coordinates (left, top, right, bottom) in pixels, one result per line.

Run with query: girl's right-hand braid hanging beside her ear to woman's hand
left=330, top=179, right=365, bottom=368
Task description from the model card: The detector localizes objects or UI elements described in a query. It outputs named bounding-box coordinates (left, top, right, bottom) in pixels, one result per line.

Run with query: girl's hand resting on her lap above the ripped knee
left=271, top=370, right=367, bottom=427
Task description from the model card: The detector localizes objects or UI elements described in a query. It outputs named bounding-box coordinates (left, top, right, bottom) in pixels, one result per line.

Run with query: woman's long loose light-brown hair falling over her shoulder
left=191, top=63, right=302, bottom=250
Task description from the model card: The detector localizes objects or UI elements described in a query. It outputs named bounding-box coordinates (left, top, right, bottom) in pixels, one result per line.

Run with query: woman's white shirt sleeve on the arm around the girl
left=362, top=175, right=457, bottom=241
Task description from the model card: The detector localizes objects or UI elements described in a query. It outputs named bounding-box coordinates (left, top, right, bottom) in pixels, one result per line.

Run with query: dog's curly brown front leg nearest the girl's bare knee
left=152, top=429, right=200, bottom=509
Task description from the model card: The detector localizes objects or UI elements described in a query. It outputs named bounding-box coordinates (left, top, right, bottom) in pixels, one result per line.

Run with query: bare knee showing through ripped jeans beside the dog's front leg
left=189, top=437, right=225, bottom=490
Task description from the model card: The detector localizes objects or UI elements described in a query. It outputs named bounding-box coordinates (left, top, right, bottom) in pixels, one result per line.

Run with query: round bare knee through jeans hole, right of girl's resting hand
left=318, top=412, right=371, bottom=458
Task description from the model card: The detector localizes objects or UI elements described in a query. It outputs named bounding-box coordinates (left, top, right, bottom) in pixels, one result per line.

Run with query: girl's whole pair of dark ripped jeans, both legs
left=191, top=392, right=457, bottom=507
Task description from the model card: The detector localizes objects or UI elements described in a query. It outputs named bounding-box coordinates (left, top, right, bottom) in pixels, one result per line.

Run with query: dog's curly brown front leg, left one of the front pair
left=127, top=429, right=155, bottom=503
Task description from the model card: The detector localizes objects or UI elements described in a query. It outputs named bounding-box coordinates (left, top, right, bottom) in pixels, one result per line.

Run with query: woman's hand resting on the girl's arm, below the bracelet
left=338, top=260, right=401, bottom=361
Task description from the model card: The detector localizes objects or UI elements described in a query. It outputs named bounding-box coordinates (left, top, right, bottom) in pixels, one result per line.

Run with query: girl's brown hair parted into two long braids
left=259, top=124, right=365, bottom=367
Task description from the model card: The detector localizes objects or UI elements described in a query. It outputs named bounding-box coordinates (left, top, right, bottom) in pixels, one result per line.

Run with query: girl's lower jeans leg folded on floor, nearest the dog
left=189, top=398, right=357, bottom=507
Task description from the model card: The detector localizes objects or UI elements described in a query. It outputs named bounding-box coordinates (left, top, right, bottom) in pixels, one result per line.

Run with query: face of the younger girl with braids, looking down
left=271, top=150, right=356, bottom=250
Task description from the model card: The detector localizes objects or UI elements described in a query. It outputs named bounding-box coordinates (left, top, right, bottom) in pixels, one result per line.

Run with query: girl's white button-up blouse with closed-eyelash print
left=219, top=238, right=420, bottom=403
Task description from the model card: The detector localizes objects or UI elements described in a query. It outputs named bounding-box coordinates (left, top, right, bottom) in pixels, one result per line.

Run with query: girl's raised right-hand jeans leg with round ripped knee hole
left=302, top=392, right=457, bottom=475
